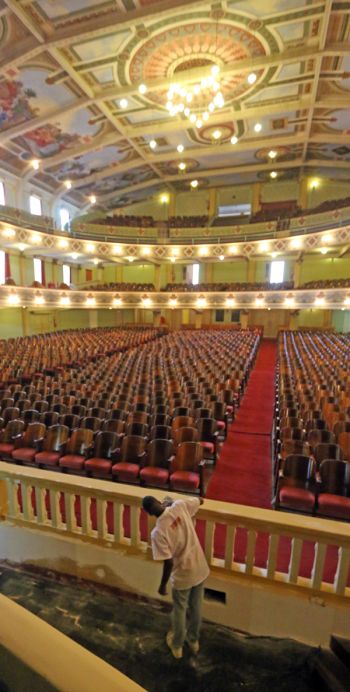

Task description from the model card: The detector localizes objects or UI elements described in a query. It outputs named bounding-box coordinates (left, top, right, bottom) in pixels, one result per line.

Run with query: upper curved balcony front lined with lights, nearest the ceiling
left=0, top=207, right=350, bottom=263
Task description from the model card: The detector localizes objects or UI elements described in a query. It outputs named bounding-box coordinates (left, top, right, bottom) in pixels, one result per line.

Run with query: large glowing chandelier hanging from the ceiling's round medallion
left=166, top=65, right=225, bottom=129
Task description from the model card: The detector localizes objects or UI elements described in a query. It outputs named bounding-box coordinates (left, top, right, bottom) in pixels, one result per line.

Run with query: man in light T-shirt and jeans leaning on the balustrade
left=142, top=495, right=209, bottom=658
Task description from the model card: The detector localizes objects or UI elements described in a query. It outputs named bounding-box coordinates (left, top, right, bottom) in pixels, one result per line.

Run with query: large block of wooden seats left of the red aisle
left=0, top=329, right=260, bottom=495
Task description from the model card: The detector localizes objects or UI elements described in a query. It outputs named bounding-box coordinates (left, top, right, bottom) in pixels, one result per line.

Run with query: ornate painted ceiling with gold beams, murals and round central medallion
left=0, top=0, right=350, bottom=208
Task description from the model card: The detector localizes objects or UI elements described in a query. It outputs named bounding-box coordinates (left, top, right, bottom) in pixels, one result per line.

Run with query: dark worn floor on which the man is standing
left=0, top=563, right=319, bottom=692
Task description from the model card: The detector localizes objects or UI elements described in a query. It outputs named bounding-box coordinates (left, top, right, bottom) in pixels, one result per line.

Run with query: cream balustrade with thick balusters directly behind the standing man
left=0, top=462, right=350, bottom=603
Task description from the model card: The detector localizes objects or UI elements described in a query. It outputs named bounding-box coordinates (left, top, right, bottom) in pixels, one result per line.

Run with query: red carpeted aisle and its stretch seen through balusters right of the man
left=202, top=340, right=344, bottom=582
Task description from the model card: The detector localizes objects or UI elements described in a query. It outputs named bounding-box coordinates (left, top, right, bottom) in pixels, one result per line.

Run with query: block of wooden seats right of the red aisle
left=274, top=332, right=350, bottom=520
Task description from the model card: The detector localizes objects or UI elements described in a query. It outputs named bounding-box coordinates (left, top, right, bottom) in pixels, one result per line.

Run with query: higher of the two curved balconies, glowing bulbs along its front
left=0, top=201, right=350, bottom=263
